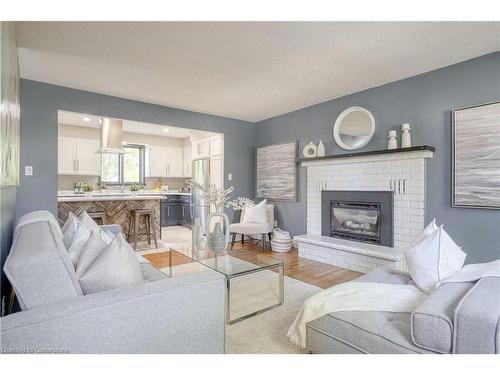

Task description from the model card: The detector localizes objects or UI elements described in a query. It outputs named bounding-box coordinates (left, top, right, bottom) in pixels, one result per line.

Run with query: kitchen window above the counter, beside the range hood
left=101, top=145, right=144, bottom=185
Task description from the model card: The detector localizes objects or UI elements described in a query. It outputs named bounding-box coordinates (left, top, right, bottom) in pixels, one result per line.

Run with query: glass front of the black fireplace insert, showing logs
left=330, top=202, right=380, bottom=243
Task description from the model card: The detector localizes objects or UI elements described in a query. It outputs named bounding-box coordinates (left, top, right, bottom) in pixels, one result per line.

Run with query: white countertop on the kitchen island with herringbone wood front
left=57, top=190, right=191, bottom=202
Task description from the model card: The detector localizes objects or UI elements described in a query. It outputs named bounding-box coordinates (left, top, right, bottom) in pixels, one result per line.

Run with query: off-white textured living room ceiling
left=17, top=22, right=500, bottom=122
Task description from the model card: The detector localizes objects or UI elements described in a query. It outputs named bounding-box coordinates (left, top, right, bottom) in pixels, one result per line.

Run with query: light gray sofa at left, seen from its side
left=0, top=215, right=225, bottom=353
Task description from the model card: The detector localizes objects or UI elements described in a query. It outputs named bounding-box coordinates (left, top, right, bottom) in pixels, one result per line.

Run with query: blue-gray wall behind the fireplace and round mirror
left=255, top=52, right=500, bottom=263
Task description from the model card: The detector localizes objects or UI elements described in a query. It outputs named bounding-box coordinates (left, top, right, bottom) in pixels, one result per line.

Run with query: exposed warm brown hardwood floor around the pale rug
left=144, top=243, right=361, bottom=288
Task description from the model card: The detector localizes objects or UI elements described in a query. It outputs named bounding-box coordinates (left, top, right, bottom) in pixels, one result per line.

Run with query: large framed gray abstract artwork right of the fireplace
left=452, top=102, right=500, bottom=209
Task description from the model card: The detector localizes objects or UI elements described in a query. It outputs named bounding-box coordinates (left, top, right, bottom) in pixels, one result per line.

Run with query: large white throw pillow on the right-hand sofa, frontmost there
left=405, top=226, right=466, bottom=293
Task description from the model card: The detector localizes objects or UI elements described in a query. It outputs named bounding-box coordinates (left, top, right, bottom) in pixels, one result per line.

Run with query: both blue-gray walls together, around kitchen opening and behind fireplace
left=16, top=52, right=500, bottom=262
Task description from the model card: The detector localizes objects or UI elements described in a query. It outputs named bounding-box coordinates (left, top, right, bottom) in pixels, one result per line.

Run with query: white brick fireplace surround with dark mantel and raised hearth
left=296, top=146, right=433, bottom=272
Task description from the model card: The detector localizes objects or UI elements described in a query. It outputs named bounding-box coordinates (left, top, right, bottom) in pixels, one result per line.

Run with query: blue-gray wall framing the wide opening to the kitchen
left=16, top=80, right=254, bottom=217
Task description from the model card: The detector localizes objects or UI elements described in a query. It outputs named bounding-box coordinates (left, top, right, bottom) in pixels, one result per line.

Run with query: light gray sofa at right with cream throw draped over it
left=306, top=268, right=500, bottom=354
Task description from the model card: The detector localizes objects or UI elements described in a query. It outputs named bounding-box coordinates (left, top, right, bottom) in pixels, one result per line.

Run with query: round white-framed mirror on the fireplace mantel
left=333, top=107, right=375, bottom=150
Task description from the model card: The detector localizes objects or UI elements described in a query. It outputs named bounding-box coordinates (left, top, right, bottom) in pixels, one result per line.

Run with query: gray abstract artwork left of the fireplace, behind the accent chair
left=256, top=141, right=297, bottom=201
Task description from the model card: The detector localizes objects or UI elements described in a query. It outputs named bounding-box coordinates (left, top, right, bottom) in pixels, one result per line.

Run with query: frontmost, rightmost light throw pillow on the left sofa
left=79, top=234, right=144, bottom=294
